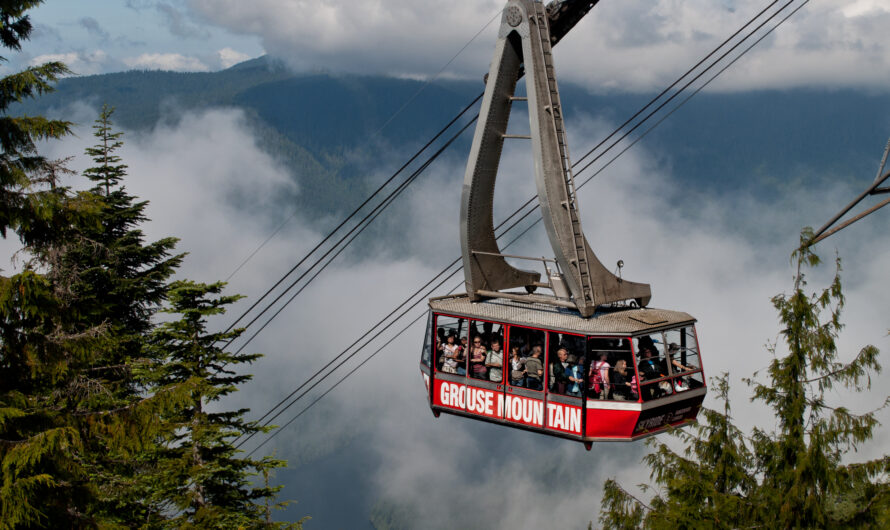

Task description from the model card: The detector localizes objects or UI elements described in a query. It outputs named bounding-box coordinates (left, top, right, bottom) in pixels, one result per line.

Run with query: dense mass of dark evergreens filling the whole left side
left=0, top=5, right=299, bottom=529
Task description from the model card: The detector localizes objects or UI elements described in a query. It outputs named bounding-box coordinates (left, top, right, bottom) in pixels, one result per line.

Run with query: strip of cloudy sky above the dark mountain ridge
left=4, top=0, right=890, bottom=91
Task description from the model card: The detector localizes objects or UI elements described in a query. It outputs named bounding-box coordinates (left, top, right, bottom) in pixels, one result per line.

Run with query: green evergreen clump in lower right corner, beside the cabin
left=600, top=230, right=890, bottom=528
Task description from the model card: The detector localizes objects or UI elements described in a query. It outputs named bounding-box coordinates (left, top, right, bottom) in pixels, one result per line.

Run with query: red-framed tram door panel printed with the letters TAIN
left=545, top=331, right=590, bottom=436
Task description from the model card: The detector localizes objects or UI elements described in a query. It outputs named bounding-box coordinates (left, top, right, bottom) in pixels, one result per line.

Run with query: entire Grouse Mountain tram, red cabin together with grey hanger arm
left=420, top=0, right=706, bottom=449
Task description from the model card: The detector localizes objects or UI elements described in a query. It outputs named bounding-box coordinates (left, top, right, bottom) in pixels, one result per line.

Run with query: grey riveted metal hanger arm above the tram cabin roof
left=461, top=0, right=651, bottom=317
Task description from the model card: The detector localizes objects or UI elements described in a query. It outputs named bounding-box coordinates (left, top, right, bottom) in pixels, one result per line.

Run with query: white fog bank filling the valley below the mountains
left=22, top=102, right=890, bottom=528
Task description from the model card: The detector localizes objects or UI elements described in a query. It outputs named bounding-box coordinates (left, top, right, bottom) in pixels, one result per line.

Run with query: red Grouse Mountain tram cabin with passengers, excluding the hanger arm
left=421, top=296, right=705, bottom=444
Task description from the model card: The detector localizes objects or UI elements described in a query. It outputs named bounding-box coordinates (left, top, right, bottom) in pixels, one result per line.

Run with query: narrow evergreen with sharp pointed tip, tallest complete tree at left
left=62, top=105, right=184, bottom=525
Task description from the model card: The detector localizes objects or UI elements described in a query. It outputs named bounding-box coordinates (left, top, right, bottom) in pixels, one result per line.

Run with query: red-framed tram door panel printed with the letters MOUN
left=504, top=326, right=547, bottom=428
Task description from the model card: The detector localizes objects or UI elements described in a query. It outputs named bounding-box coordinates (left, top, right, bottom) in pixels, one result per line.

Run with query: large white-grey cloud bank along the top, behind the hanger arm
left=189, top=0, right=890, bottom=91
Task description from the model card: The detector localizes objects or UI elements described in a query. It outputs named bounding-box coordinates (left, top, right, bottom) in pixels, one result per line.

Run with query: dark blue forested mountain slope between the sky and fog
left=15, top=57, right=890, bottom=220
